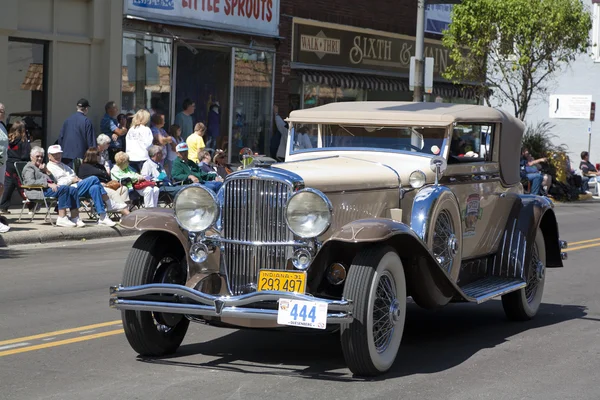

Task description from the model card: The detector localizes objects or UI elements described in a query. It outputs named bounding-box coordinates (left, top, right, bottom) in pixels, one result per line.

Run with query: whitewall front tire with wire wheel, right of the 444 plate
left=340, top=246, right=406, bottom=376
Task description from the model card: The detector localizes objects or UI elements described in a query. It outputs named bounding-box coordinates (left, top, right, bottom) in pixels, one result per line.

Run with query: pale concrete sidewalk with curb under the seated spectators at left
left=0, top=207, right=140, bottom=248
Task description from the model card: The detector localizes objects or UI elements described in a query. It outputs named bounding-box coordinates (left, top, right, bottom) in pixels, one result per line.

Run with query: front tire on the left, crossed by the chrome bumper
left=121, top=232, right=190, bottom=356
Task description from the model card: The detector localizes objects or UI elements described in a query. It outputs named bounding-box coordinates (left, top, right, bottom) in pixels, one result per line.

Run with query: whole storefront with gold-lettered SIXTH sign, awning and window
left=290, top=18, right=478, bottom=109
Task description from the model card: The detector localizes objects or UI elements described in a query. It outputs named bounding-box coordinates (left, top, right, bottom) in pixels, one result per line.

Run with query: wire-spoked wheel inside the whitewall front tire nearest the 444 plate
left=373, top=271, right=400, bottom=353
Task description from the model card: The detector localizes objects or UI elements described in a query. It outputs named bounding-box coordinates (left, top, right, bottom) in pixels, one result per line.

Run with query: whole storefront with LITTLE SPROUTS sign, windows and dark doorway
left=121, top=0, right=279, bottom=162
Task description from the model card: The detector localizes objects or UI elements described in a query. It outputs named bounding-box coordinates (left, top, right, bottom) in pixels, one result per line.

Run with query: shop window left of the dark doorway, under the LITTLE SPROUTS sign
left=121, top=33, right=173, bottom=124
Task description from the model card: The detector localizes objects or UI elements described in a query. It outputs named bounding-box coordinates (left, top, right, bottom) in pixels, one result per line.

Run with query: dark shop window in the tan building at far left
left=2, top=38, right=48, bottom=146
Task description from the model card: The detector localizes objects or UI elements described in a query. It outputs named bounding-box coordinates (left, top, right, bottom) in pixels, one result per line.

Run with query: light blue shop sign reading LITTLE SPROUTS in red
left=124, top=0, right=279, bottom=36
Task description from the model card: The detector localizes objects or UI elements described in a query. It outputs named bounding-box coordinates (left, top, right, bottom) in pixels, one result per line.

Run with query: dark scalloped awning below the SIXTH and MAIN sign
left=297, top=70, right=490, bottom=99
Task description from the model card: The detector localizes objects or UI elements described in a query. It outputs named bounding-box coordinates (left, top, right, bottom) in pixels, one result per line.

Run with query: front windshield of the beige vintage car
left=291, top=124, right=446, bottom=155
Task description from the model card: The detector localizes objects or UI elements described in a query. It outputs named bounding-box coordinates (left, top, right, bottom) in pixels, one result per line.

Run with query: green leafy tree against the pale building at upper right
left=443, top=0, right=592, bottom=120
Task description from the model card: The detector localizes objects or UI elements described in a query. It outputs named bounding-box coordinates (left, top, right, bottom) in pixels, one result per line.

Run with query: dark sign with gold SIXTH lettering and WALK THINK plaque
left=292, top=21, right=466, bottom=78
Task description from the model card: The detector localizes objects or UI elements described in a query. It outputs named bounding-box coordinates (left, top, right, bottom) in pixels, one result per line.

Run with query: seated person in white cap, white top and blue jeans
left=47, top=144, right=116, bottom=227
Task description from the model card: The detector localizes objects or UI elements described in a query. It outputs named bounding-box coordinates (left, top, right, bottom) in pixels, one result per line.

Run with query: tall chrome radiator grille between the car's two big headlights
left=221, top=179, right=293, bottom=295
